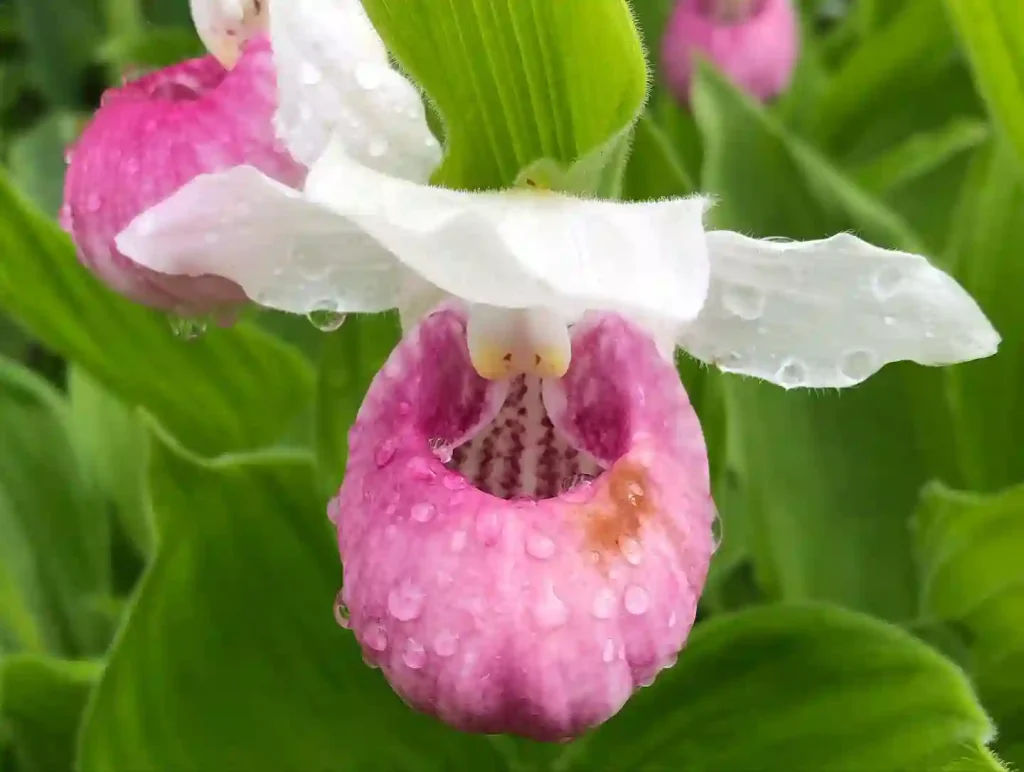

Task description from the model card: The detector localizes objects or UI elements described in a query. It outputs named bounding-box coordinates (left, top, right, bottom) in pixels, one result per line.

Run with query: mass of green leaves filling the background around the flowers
left=0, top=0, right=1024, bottom=772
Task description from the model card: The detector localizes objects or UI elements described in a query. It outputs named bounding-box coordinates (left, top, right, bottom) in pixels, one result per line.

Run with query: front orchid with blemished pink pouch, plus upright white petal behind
left=110, top=0, right=998, bottom=740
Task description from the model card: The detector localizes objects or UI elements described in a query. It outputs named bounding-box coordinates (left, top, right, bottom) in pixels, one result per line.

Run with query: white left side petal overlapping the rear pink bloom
left=117, top=166, right=416, bottom=313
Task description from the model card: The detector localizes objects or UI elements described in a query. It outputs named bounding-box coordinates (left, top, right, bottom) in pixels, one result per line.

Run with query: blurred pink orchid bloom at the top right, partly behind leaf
left=662, top=0, right=800, bottom=102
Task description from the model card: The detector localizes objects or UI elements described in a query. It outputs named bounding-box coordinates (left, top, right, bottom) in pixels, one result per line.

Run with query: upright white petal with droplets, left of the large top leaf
left=270, top=0, right=441, bottom=181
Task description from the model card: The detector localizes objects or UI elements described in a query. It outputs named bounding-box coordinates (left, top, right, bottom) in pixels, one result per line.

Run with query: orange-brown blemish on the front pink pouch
left=583, top=459, right=656, bottom=562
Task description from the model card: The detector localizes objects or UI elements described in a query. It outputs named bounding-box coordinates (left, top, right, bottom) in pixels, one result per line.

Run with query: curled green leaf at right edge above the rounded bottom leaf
left=914, top=485, right=1024, bottom=765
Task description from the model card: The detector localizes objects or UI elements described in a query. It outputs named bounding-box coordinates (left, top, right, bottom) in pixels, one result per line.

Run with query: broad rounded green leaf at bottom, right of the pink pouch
left=555, top=606, right=1000, bottom=772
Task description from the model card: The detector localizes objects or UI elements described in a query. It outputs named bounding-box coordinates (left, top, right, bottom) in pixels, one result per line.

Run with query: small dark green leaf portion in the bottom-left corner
left=0, top=655, right=100, bottom=772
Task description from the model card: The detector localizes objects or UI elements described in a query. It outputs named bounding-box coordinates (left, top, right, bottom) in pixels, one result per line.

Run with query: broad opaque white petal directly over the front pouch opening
left=306, top=143, right=709, bottom=321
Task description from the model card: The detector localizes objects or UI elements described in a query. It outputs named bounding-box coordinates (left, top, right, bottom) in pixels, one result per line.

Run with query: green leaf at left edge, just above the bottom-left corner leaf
left=0, top=360, right=111, bottom=653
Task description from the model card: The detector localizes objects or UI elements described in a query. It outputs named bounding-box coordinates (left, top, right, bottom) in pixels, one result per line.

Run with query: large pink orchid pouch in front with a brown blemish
left=329, top=309, right=715, bottom=740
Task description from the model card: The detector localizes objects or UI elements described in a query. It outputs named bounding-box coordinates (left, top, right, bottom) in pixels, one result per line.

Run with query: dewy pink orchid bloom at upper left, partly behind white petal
left=60, top=0, right=304, bottom=315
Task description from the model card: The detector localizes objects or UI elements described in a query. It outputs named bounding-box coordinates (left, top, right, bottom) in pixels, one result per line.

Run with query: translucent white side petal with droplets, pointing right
left=679, top=230, right=999, bottom=388
